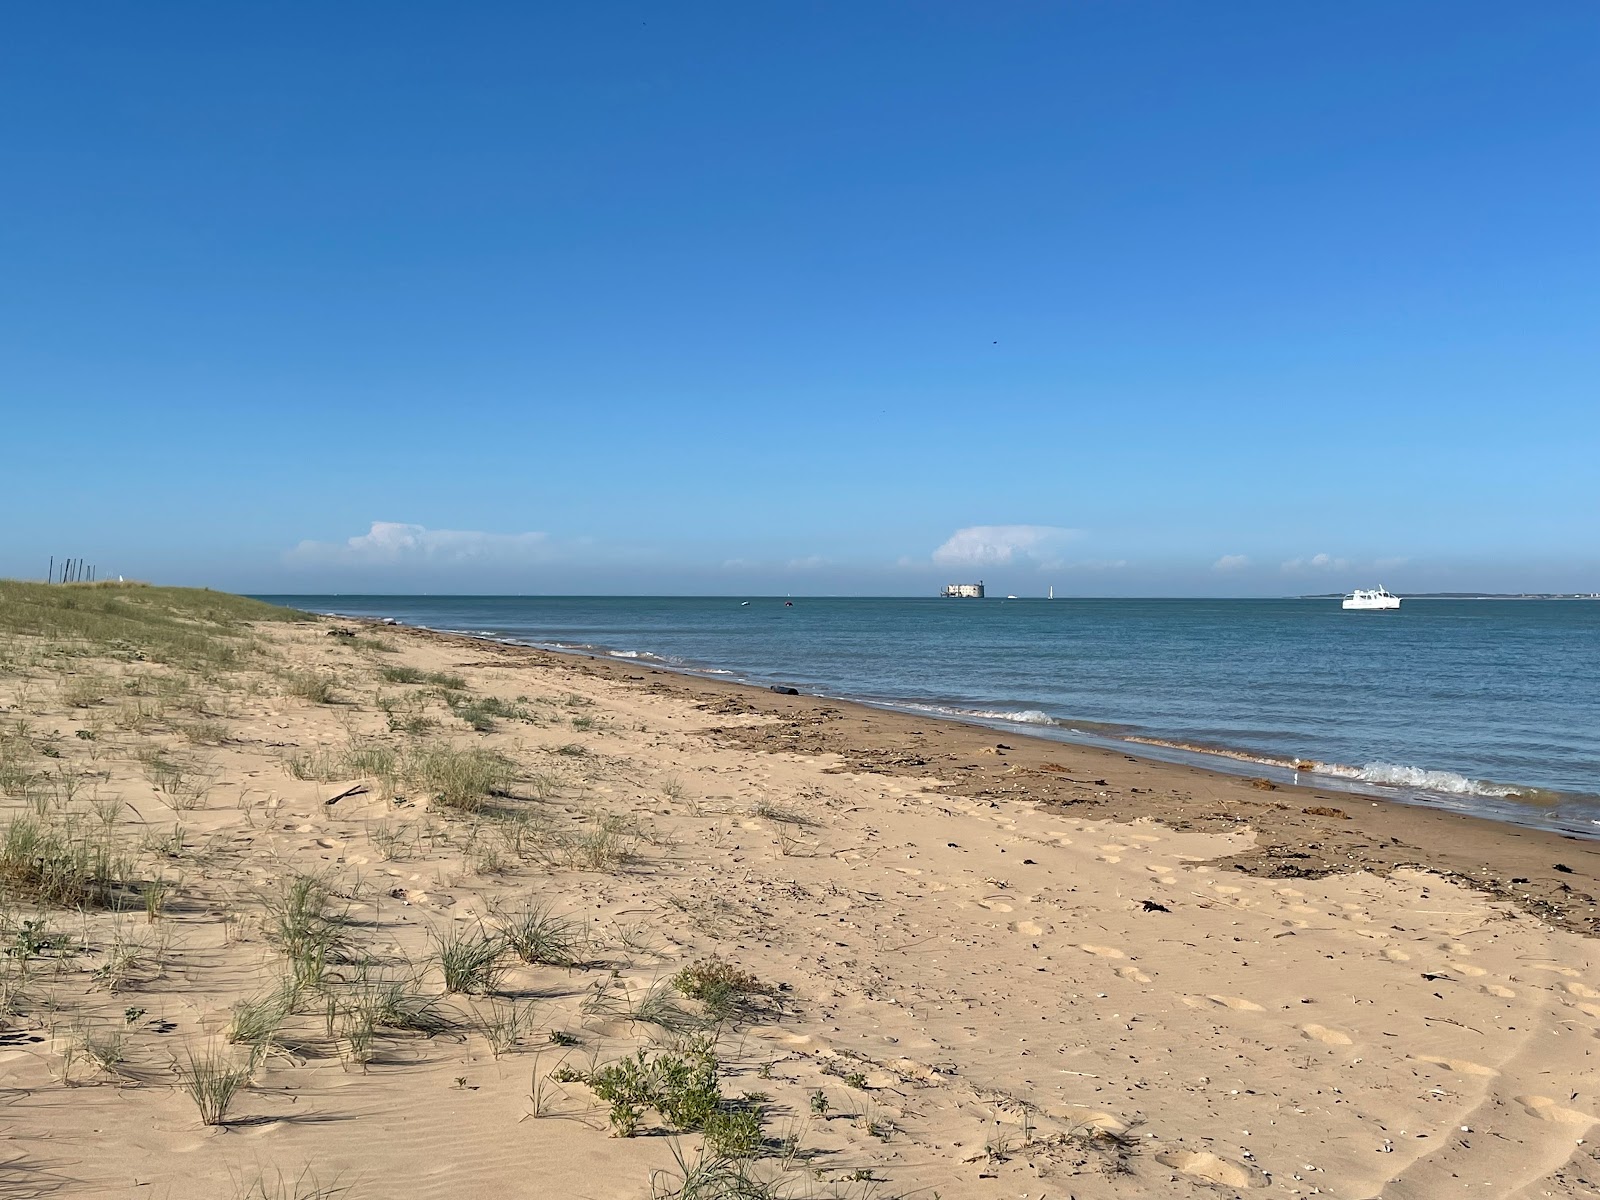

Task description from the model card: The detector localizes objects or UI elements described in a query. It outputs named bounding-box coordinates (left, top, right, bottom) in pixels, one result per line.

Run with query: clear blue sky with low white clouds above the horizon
left=0, top=0, right=1600, bottom=595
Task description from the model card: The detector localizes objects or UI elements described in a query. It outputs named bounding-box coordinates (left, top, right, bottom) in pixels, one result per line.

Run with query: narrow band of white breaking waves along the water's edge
left=314, top=610, right=1600, bottom=842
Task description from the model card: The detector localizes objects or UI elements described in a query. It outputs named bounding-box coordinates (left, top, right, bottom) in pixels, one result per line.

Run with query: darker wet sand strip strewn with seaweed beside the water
left=360, top=614, right=1600, bottom=938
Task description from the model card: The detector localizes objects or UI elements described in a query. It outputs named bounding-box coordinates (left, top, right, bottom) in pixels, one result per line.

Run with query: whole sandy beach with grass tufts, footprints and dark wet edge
left=0, top=584, right=1600, bottom=1200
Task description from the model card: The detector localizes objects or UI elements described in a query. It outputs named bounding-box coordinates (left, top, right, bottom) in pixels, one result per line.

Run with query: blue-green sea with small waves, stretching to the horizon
left=261, top=595, right=1600, bottom=837
